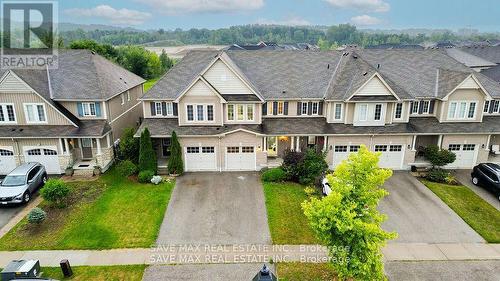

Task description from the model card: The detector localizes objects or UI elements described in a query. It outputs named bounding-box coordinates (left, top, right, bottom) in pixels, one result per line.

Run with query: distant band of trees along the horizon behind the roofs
left=60, top=24, right=500, bottom=48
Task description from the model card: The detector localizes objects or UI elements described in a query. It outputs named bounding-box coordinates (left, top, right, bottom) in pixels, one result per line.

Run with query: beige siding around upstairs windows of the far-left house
left=0, top=93, right=71, bottom=125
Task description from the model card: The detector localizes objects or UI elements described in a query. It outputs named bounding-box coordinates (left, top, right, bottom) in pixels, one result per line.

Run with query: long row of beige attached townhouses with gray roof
left=136, top=50, right=500, bottom=171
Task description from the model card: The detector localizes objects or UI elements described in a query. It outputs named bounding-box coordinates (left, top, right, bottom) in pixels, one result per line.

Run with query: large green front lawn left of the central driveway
left=0, top=169, right=174, bottom=250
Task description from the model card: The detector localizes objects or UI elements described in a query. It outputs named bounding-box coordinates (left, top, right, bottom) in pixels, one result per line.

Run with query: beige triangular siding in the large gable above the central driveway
left=203, top=60, right=253, bottom=94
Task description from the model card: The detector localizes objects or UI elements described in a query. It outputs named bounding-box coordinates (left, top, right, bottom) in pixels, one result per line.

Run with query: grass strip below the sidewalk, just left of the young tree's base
left=276, top=262, right=337, bottom=281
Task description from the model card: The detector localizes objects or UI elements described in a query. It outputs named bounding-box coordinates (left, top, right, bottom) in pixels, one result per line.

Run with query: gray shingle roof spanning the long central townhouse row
left=144, top=49, right=500, bottom=100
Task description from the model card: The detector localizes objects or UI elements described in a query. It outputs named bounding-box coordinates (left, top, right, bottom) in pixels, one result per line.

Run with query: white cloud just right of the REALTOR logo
left=64, top=5, right=151, bottom=25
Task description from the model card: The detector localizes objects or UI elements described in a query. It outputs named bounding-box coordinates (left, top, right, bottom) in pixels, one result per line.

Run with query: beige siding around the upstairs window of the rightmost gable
left=439, top=89, right=485, bottom=122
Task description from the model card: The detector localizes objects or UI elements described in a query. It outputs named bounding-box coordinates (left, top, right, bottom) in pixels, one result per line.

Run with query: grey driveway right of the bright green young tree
left=379, top=172, right=484, bottom=243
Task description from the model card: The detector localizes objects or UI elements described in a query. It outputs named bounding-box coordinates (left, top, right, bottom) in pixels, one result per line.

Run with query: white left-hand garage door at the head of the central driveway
left=184, top=146, right=217, bottom=171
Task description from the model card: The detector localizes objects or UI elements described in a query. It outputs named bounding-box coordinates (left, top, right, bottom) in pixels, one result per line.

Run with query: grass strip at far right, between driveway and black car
left=422, top=180, right=500, bottom=243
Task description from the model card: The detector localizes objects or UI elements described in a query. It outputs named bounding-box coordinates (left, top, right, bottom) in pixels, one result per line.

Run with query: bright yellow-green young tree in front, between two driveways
left=302, top=146, right=397, bottom=280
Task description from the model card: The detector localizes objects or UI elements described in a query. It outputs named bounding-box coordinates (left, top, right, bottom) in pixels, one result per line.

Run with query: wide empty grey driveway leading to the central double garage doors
left=157, top=172, right=271, bottom=245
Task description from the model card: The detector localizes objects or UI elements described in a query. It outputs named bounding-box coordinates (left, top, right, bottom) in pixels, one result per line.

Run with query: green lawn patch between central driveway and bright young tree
left=263, top=183, right=318, bottom=245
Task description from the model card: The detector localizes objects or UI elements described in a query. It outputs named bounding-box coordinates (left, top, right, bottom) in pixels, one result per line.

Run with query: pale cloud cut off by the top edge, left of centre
left=136, top=0, right=264, bottom=14
